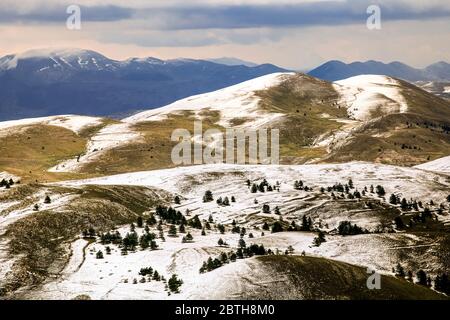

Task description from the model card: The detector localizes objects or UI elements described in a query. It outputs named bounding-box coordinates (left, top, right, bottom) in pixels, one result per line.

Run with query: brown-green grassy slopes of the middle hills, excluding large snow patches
left=0, top=74, right=450, bottom=182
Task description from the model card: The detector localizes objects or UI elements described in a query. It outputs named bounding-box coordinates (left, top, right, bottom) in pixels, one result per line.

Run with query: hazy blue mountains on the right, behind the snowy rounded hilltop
left=308, top=60, right=450, bottom=82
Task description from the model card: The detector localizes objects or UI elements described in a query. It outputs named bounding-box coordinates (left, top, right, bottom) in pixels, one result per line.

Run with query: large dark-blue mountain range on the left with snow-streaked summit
left=0, top=49, right=286, bottom=120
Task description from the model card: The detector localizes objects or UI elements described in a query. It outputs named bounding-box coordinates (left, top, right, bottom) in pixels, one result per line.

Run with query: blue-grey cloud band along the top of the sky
left=0, top=0, right=450, bottom=30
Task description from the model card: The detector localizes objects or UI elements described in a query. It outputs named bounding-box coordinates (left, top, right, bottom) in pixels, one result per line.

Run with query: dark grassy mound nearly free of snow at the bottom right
left=242, top=256, right=445, bottom=300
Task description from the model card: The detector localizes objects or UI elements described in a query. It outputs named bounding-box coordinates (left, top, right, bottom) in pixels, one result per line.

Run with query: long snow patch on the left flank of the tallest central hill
left=123, top=73, right=293, bottom=128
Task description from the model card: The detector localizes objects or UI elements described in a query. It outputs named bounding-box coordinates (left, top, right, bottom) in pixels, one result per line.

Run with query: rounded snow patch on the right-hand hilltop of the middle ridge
left=334, top=75, right=408, bottom=121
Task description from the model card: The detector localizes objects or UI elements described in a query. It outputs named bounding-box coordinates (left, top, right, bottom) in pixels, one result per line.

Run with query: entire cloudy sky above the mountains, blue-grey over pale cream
left=0, top=0, right=450, bottom=70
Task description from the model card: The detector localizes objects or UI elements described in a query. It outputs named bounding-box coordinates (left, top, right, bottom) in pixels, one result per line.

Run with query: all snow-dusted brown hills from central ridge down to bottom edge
left=0, top=70, right=450, bottom=299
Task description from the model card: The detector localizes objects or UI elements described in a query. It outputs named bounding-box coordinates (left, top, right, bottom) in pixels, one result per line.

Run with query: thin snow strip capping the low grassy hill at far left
left=0, top=115, right=102, bottom=134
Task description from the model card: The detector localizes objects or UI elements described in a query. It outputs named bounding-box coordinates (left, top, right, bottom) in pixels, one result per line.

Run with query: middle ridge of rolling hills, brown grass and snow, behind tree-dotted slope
left=0, top=73, right=450, bottom=182
